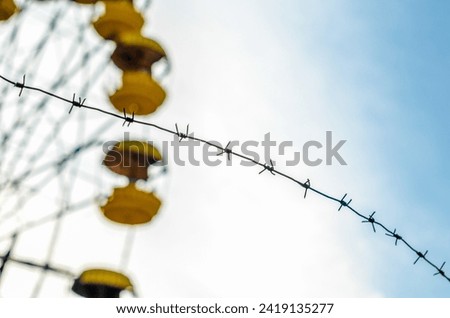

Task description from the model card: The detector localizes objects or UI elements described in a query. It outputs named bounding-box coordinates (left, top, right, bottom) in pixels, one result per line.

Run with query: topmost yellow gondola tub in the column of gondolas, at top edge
left=93, top=0, right=144, bottom=40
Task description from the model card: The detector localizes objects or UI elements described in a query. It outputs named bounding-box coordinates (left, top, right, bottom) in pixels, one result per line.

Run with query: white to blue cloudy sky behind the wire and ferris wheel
left=0, top=0, right=450, bottom=298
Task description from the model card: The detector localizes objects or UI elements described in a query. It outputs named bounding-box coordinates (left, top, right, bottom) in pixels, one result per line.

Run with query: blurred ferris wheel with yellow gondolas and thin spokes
left=0, top=0, right=169, bottom=298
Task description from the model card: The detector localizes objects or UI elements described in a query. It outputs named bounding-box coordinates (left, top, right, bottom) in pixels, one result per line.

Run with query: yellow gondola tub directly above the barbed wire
left=109, top=71, right=166, bottom=115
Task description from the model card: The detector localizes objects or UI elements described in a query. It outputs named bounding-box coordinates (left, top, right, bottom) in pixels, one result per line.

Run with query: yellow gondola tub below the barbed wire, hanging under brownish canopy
left=100, top=183, right=161, bottom=225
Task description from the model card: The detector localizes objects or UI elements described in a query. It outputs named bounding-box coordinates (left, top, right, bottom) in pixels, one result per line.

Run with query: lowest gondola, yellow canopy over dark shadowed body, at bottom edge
left=72, top=268, right=133, bottom=298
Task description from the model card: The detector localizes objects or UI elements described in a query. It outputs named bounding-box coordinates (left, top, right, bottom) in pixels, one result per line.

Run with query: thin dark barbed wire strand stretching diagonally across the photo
left=0, top=75, right=450, bottom=282
